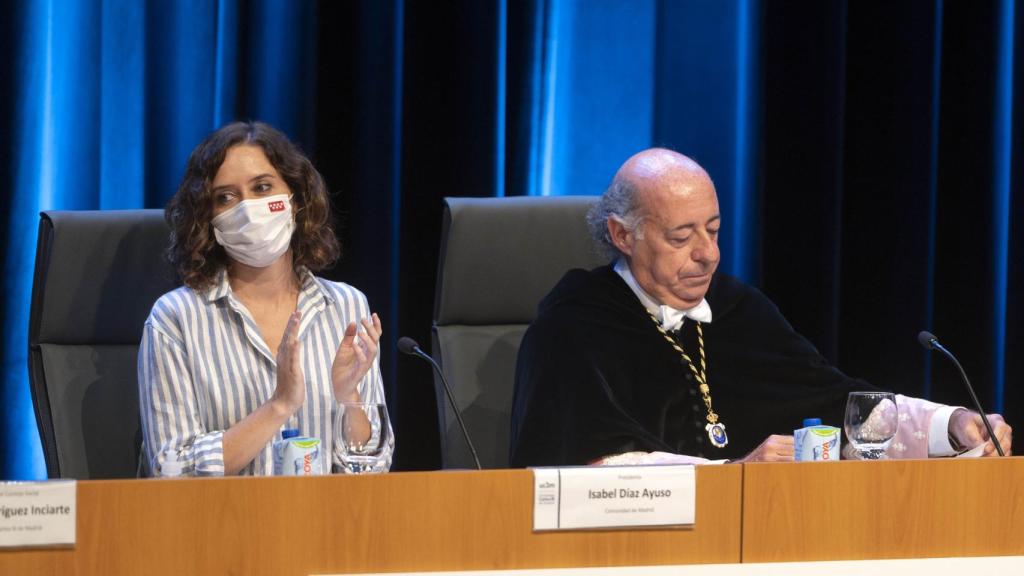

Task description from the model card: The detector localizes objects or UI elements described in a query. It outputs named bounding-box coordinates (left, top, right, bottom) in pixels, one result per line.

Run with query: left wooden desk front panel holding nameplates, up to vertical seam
left=0, top=465, right=742, bottom=575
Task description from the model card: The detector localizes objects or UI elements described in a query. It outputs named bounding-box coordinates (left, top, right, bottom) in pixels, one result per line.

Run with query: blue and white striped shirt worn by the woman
left=138, top=271, right=394, bottom=476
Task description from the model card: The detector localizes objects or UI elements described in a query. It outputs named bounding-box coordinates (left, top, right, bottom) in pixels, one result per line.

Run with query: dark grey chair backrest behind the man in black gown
left=432, top=196, right=606, bottom=468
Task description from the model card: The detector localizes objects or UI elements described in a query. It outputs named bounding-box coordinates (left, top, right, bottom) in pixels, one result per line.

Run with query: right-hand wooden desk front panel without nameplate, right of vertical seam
left=742, top=457, right=1024, bottom=562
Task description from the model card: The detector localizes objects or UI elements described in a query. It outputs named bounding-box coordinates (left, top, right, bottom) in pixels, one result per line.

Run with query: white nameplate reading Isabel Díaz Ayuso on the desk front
left=534, top=465, right=696, bottom=530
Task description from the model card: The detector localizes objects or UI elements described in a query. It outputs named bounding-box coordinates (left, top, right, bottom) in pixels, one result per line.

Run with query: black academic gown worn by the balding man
left=510, top=265, right=874, bottom=467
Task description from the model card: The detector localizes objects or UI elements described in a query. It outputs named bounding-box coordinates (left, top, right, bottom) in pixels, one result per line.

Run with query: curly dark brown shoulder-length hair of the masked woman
left=164, top=122, right=341, bottom=290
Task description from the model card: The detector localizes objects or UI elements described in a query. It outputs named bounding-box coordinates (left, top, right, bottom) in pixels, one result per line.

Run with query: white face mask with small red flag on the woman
left=213, top=194, right=295, bottom=268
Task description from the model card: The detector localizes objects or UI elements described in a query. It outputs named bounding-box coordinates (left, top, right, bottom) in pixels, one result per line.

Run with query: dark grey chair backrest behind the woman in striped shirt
left=29, top=210, right=176, bottom=479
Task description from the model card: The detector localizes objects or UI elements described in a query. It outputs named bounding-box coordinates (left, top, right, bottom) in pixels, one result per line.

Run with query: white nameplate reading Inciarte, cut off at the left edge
left=0, top=480, right=78, bottom=547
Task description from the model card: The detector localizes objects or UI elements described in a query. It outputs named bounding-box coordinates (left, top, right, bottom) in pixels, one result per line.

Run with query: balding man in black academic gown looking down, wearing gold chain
left=510, top=149, right=1012, bottom=466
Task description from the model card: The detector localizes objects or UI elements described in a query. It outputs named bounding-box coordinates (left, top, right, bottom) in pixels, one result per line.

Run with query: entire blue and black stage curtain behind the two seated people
left=0, top=0, right=1024, bottom=478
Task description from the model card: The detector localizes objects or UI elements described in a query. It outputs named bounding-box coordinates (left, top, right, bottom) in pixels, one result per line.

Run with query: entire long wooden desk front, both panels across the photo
left=0, top=457, right=1024, bottom=576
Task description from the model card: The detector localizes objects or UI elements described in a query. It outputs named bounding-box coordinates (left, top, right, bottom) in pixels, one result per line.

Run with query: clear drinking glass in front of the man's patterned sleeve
left=843, top=392, right=899, bottom=460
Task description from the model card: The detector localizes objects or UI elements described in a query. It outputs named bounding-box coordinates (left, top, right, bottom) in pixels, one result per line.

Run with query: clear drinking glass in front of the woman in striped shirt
left=338, top=402, right=391, bottom=474
